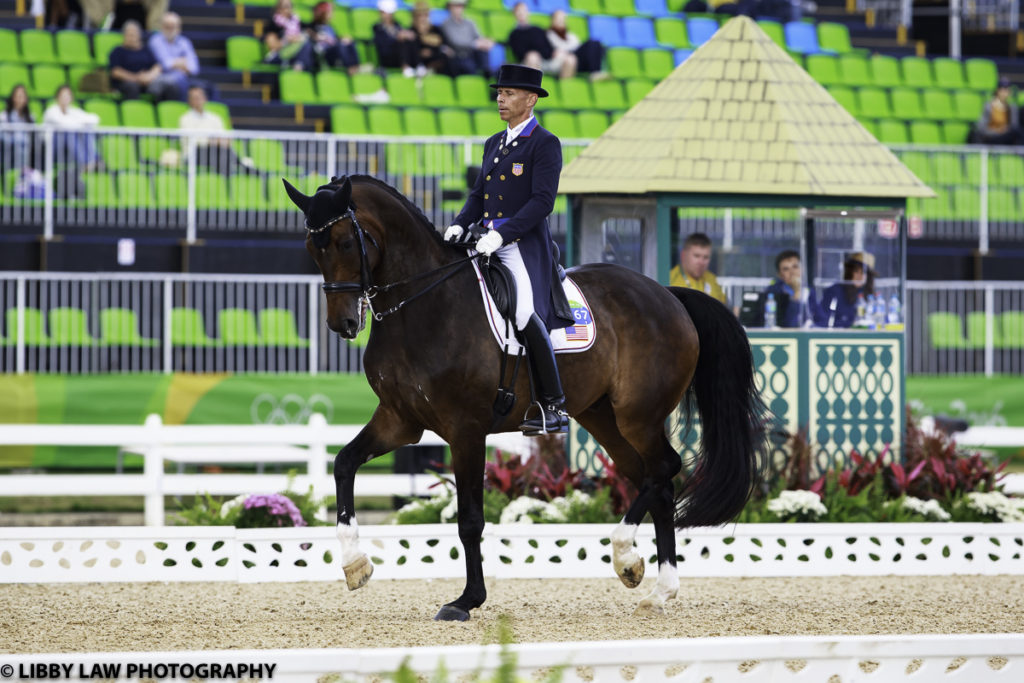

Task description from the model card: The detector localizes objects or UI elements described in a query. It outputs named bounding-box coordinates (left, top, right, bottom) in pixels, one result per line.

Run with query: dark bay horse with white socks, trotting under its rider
left=284, top=175, right=765, bottom=621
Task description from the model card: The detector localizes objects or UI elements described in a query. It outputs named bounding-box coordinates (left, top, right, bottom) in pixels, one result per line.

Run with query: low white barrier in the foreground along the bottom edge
left=2, top=634, right=1024, bottom=683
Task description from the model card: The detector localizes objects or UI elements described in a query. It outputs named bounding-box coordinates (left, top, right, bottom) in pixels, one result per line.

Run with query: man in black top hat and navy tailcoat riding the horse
left=444, top=65, right=573, bottom=435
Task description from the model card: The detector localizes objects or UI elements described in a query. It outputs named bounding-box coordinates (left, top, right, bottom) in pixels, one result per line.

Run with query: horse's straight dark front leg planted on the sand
left=434, top=437, right=487, bottom=622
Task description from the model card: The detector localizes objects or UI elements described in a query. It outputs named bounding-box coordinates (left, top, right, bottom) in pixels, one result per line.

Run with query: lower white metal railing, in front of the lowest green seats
left=0, top=272, right=1024, bottom=375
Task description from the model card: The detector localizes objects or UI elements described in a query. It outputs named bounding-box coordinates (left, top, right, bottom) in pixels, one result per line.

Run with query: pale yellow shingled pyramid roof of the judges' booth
left=558, top=16, right=935, bottom=198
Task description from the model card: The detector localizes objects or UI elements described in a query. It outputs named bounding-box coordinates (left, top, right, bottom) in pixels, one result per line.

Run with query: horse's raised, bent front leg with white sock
left=334, top=405, right=423, bottom=591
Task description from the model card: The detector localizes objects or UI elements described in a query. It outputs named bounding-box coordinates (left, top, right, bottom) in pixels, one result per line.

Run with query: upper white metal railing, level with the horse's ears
left=0, top=122, right=1024, bottom=253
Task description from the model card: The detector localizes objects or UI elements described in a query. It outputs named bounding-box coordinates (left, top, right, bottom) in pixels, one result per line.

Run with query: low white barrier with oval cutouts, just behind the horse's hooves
left=0, top=523, right=1024, bottom=583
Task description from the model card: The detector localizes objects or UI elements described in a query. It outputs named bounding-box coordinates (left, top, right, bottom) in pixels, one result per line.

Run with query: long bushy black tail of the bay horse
left=669, top=287, right=767, bottom=528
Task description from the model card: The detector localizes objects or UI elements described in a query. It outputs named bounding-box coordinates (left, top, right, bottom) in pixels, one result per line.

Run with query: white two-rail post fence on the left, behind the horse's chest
left=0, top=414, right=530, bottom=526
